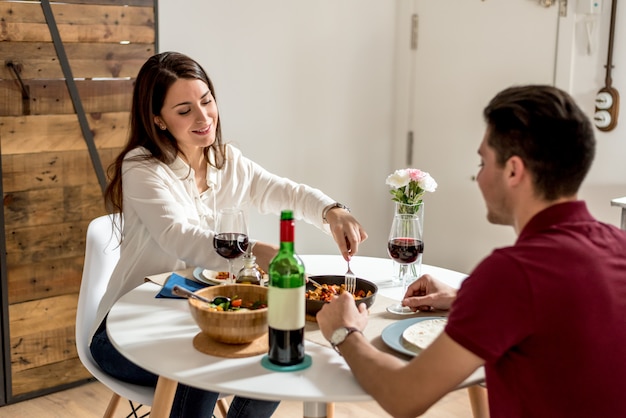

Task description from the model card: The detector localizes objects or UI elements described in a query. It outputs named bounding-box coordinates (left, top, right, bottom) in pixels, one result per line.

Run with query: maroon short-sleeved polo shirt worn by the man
left=446, top=201, right=626, bottom=418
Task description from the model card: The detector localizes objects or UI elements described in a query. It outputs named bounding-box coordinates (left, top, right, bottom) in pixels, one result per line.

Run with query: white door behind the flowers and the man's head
left=394, top=0, right=559, bottom=272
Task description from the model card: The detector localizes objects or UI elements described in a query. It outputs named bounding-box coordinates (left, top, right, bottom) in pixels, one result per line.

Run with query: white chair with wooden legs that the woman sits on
left=76, top=215, right=228, bottom=418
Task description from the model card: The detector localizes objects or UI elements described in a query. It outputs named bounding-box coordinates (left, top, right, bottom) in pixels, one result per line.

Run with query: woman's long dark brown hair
left=104, top=52, right=224, bottom=213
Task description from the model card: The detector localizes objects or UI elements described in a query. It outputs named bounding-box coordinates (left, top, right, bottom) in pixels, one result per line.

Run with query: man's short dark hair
left=483, top=85, right=596, bottom=200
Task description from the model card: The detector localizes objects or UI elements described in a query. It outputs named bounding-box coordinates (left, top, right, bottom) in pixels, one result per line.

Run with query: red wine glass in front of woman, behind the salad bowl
left=213, top=208, right=248, bottom=283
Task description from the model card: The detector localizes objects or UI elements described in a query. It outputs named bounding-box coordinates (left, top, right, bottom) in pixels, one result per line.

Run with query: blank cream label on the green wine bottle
left=267, top=286, right=306, bottom=331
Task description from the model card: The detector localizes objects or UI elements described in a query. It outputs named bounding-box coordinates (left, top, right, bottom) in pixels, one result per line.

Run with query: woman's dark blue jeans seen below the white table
left=89, top=318, right=279, bottom=418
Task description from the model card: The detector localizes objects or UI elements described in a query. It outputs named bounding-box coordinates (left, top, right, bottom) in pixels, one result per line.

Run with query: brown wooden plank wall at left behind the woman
left=0, top=0, right=156, bottom=402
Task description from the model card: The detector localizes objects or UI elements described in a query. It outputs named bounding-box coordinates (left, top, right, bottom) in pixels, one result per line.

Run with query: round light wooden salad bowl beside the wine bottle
left=188, top=284, right=267, bottom=344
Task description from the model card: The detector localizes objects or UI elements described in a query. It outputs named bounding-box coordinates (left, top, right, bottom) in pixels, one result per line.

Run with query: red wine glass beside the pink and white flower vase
left=387, top=214, right=424, bottom=314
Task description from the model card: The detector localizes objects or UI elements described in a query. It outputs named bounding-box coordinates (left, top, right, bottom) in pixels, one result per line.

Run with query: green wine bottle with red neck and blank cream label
left=267, top=210, right=306, bottom=366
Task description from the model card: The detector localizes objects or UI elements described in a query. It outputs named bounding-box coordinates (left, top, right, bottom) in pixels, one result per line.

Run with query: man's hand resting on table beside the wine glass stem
left=402, top=274, right=456, bottom=311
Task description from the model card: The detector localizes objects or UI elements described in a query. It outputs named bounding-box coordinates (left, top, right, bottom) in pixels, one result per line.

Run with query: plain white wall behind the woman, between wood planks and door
left=158, top=0, right=395, bottom=257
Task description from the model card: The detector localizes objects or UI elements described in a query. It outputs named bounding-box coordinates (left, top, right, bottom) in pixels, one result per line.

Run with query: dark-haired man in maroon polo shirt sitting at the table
left=317, top=86, right=626, bottom=418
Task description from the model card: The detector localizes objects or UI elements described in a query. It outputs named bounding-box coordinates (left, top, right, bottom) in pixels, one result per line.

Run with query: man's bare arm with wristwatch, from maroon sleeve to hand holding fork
left=317, top=294, right=484, bottom=417
